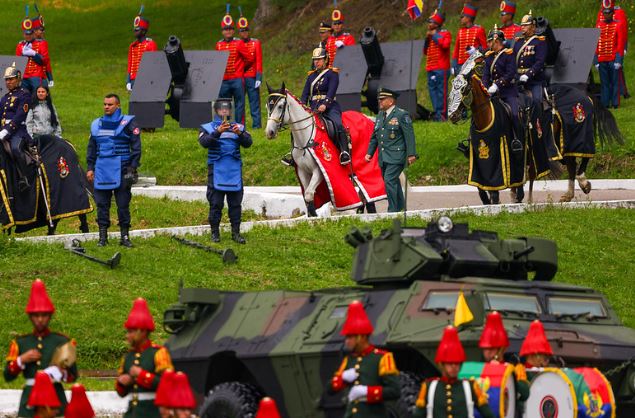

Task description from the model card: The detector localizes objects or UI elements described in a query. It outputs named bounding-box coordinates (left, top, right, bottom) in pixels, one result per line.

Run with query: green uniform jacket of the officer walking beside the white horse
left=367, top=106, right=417, bottom=166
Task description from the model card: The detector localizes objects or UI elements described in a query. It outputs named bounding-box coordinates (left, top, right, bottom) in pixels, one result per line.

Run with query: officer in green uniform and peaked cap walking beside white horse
left=366, top=87, right=417, bottom=212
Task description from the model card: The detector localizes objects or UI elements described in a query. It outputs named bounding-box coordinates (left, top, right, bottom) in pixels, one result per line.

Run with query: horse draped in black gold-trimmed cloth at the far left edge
left=0, top=135, right=93, bottom=235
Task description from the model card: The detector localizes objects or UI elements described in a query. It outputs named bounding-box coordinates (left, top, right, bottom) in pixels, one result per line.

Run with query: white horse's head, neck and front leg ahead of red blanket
left=265, top=83, right=324, bottom=216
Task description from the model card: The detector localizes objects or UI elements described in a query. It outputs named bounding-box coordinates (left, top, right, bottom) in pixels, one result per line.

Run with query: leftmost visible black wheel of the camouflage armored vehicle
left=201, top=382, right=260, bottom=418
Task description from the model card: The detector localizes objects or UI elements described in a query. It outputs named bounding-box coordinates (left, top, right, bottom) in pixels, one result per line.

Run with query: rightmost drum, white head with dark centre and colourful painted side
left=525, top=367, right=615, bottom=418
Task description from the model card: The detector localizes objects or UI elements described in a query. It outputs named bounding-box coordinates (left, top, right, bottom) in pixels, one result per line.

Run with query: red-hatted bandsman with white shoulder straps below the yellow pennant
left=413, top=326, right=494, bottom=418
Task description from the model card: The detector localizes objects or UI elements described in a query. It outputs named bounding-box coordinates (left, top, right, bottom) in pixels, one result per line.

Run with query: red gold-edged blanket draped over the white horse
left=298, top=111, right=386, bottom=210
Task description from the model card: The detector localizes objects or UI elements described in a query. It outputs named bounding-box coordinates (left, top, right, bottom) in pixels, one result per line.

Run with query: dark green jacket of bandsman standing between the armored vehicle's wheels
left=331, top=346, right=400, bottom=418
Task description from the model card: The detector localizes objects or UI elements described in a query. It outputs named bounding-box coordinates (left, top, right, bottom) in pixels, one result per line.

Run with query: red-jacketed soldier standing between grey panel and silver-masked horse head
left=423, top=10, right=452, bottom=122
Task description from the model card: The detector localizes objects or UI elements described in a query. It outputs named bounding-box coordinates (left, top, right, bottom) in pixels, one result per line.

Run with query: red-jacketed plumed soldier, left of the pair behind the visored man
left=216, top=4, right=254, bottom=125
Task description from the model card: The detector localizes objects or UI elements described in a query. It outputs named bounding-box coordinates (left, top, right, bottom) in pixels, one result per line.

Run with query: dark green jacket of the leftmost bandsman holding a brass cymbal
left=4, top=329, right=77, bottom=418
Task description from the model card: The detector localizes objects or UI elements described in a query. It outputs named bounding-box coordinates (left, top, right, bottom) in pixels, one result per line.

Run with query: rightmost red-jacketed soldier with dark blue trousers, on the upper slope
left=594, top=3, right=625, bottom=109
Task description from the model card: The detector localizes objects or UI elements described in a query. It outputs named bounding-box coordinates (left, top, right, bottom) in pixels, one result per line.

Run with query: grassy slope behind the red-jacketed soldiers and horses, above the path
left=0, top=0, right=635, bottom=185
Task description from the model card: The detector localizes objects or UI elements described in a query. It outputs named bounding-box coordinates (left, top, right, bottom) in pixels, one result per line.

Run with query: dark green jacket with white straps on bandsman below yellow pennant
left=413, top=378, right=494, bottom=418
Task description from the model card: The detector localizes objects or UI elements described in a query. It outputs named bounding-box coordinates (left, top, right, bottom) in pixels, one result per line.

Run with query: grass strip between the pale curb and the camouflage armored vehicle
left=0, top=208, right=635, bottom=386
